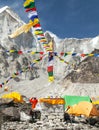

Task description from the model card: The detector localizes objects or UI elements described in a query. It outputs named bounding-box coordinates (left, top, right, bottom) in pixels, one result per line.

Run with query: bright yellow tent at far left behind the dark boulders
left=2, top=92, right=24, bottom=103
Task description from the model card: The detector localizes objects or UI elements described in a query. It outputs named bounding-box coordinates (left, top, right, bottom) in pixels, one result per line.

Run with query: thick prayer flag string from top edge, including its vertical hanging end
left=24, top=0, right=54, bottom=82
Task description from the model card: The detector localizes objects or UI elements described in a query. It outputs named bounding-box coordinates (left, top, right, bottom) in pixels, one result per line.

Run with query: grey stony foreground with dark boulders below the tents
left=0, top=100, right=99, bottom=130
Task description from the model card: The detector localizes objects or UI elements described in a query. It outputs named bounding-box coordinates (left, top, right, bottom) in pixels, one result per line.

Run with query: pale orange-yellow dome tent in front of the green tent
left=67, top=101, right=99, bottom=117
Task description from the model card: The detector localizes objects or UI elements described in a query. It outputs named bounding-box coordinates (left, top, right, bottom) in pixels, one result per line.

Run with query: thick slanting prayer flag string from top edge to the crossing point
left=23, top=0, right=48, bottom=49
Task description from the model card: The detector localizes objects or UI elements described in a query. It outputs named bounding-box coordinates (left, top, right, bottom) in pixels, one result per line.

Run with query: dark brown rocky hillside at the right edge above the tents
left=66, top=50, right=99, bottom=83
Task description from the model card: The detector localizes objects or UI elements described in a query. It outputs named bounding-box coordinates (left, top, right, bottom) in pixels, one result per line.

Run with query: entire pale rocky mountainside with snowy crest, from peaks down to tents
left=0, top=7, right=99, bottom=97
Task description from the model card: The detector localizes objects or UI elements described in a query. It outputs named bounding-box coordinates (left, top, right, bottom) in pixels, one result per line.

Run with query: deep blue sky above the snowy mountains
left=0, top=0, right=99, bottom=38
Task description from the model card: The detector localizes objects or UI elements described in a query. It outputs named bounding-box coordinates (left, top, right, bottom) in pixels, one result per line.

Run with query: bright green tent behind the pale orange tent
left=62, top=95, right=91, bottom=109
